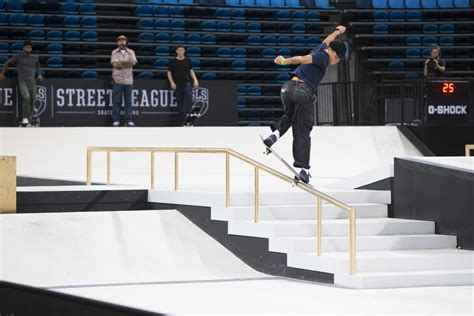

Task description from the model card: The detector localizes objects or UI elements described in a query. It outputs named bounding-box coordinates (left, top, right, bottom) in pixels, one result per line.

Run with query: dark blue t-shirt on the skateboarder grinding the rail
left=291, top=44, right=329, bottom=92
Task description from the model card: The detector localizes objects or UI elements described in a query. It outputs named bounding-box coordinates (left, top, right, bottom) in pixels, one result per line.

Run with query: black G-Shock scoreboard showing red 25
left=424, top=80, right=472, bottom=126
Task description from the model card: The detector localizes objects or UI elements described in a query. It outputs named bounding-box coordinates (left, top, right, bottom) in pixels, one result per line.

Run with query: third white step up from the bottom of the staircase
left=269, top=234, right=457, bottom=253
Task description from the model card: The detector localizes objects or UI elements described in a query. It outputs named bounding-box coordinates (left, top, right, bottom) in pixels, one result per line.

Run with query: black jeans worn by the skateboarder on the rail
left=270, top=80, right=316, bottom=169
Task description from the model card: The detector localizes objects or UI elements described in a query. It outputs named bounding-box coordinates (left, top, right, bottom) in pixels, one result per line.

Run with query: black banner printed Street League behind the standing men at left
left=0, top=79, right=237, bottom=126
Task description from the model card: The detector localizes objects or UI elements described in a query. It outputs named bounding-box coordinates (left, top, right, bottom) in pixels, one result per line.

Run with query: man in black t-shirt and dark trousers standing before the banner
left=168, top=46, right=199, bottom=126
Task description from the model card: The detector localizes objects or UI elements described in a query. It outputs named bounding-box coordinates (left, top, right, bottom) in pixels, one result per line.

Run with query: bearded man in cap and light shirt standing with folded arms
left=110, top=35, right=138, bottom=127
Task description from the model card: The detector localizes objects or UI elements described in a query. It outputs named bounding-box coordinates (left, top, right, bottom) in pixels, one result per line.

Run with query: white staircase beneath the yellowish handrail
left=150, top=189, right=474, bottom=288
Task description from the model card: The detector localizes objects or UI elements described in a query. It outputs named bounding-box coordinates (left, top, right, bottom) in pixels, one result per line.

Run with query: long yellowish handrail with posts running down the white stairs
left=87, top=147, right=356, bottom=274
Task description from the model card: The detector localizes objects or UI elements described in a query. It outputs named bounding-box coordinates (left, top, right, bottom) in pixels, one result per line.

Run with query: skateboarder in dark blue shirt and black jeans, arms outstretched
left=264, top=25, right=346, bottom=183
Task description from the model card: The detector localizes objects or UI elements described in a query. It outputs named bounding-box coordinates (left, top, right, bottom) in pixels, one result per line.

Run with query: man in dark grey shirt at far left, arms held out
left=0, top=40, right=43, bottom=126
